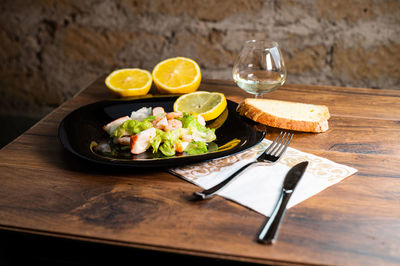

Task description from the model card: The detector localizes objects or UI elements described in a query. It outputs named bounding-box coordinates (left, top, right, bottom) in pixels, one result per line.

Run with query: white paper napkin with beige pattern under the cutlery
left=170, top=139, right=357, bottom=216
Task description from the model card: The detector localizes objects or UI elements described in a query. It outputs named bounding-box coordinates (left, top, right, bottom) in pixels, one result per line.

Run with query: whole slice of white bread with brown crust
left=237, top=98, right=330, bottom=133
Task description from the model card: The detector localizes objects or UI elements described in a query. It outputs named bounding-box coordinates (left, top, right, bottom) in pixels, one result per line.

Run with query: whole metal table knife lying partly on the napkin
left=258, top=161, right=308, bottom=244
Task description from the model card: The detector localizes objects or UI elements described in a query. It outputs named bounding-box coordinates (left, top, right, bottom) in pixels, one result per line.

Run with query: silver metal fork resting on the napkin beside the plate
left=193, top=131, right=293, bottom=200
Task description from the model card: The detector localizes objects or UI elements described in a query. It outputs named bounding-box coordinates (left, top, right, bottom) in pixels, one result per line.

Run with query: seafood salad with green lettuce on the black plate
left=103, top=107, right=216, bottom=156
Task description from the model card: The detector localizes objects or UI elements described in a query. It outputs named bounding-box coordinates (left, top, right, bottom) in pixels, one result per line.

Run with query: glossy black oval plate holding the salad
left=58, top=96, right=265, bottom=167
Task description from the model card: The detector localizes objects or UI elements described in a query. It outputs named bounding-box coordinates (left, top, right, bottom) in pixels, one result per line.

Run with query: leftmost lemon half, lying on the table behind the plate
left=105, top=68, right=153, bottom=97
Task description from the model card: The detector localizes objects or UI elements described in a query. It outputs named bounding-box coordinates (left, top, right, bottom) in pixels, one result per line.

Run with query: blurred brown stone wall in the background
left=0, top=0, right=400, bottom=117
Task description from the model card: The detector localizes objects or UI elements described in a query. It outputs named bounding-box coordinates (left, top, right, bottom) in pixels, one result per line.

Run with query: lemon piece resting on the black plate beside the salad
left=174, top=91, right=227, bottom=121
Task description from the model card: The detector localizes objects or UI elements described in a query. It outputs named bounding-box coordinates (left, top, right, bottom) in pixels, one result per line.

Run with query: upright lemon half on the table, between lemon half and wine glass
left=152, top=57, right=201, bottom=93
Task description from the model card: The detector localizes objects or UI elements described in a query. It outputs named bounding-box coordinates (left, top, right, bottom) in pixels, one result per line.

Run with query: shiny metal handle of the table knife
left=258, top=190, right=293, bottom=244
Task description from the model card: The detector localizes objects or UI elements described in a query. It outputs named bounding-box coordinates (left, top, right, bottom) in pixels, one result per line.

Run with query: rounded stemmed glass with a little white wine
left=232, top=40, right=286, bottom=98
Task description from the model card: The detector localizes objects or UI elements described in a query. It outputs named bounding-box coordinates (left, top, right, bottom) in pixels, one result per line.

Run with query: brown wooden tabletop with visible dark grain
left=0, top=77, right=400, bottom=265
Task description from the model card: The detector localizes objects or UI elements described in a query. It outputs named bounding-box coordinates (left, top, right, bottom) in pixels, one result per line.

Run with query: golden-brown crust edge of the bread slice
left=237, top=101, right=329, bottom=133
